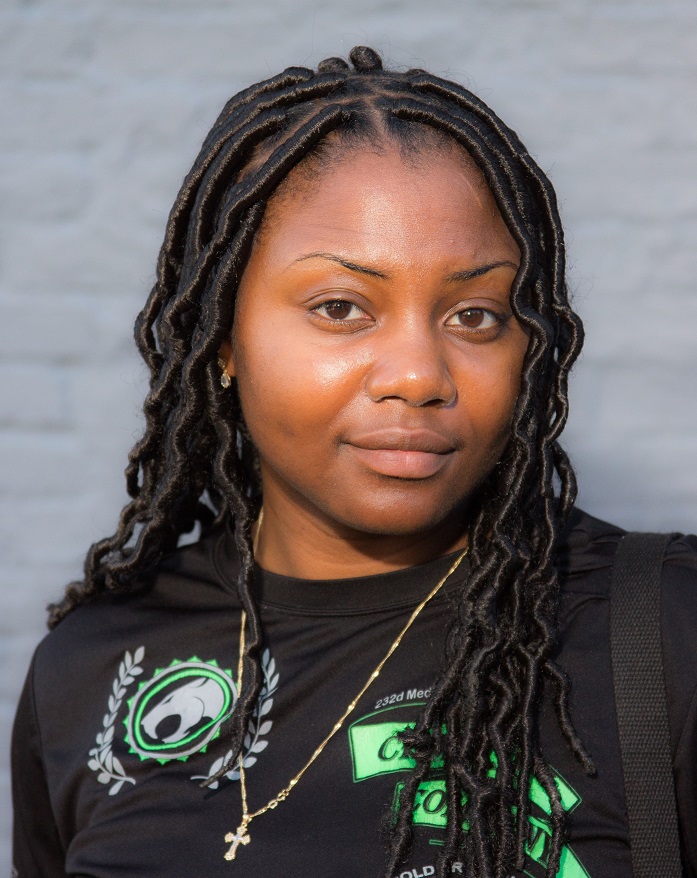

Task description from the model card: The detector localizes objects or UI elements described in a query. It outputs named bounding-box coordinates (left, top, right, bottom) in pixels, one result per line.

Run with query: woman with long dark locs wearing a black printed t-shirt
left=13, top=48, right=697, bottom=878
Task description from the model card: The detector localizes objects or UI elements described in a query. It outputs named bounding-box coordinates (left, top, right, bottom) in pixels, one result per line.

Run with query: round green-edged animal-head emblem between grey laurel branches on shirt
left=124, top=658, right=237, bottom=762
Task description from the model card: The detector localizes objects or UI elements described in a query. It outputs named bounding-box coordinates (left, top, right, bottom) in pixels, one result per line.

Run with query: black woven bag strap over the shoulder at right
left=610, top=533, right=682, bottom=878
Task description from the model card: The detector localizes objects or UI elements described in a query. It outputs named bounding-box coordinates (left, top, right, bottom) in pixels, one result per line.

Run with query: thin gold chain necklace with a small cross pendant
left=225, top=509, right=467, bottom=860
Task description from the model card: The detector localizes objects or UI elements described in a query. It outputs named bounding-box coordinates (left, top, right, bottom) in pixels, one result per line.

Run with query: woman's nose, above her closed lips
left=366, top=328, right=457, bottom=407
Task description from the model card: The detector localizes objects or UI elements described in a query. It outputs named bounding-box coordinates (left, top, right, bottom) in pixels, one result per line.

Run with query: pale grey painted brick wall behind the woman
left=0, top=0, right=697, bottom=874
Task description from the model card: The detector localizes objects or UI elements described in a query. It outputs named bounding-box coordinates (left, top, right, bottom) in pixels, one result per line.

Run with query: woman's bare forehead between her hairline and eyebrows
left=255, top=144, right=519, bottom=274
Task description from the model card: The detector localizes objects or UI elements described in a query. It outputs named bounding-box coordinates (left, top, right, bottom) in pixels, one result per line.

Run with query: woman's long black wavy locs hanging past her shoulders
left=49, top=47, right=592, bottom=878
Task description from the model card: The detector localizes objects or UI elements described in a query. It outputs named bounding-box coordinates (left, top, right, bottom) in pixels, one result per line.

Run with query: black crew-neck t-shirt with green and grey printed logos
left=12, top=513, right=697, bottom=878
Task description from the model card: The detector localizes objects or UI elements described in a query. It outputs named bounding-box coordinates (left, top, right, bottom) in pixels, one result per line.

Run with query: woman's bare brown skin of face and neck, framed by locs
left=221, top=144, right=527, bottom=579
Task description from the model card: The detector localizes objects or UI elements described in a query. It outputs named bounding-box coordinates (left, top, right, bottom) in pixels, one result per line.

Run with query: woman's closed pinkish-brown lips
left=345, top=428, right=455, bottom=479
